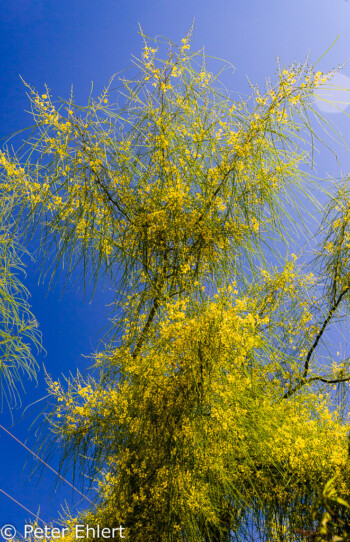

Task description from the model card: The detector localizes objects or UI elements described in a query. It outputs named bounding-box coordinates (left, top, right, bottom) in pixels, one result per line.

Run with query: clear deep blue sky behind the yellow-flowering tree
left=0, top=0, right=350, bottom=532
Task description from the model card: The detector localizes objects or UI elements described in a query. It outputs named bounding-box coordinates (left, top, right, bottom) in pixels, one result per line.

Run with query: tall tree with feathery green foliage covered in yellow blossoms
left=2, top=30, right=350, bottom=542
